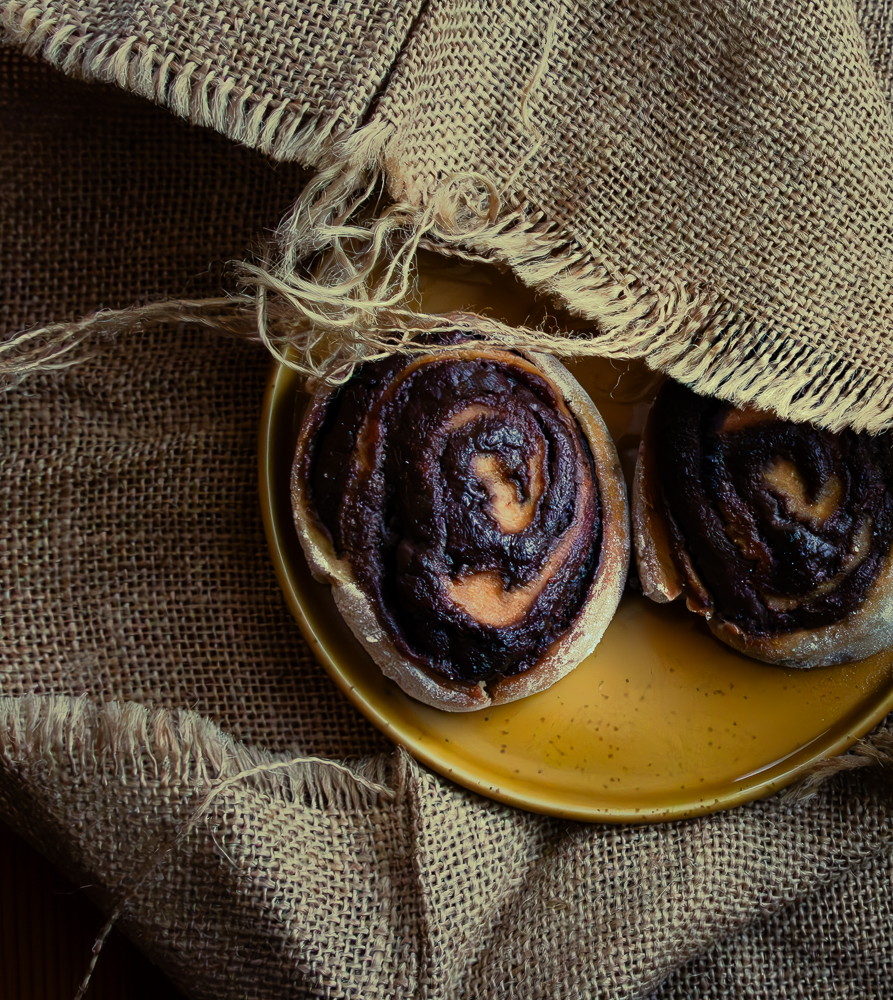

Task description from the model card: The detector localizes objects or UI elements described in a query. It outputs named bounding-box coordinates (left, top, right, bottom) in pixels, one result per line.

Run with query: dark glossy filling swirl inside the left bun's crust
left=303, top=348, right=601, bottom=682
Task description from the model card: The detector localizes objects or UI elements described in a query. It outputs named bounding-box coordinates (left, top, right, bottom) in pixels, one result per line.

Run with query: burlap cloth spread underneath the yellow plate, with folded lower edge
left=0, top=5, right=893, bottom=998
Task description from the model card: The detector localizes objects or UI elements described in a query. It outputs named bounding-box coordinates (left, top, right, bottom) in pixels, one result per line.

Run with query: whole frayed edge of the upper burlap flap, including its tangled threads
left=0, top=0, right=893, bottom=433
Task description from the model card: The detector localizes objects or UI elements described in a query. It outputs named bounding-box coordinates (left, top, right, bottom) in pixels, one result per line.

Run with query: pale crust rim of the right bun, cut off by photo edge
left=632, top=427, right=893, bottom=669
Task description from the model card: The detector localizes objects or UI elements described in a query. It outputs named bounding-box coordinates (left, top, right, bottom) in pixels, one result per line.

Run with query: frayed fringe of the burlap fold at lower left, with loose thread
left=0, top=695, right=405, bottom=1000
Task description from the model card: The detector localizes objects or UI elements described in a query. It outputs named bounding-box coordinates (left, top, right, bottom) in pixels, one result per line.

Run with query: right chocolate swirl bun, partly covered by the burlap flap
left=633, top=382, right=893, bottom=667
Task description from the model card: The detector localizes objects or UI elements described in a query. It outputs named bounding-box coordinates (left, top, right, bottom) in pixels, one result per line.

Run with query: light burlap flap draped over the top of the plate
left=2, top=0, right=893, bottom=431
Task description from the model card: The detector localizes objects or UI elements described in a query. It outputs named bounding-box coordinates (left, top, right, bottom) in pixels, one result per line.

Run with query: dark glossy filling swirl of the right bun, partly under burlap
left=649, top=383, right=893, bottom=634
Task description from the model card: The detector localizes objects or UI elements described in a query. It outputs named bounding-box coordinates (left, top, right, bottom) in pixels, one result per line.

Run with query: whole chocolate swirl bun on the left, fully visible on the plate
left=292, top=340, right=629, bottom=711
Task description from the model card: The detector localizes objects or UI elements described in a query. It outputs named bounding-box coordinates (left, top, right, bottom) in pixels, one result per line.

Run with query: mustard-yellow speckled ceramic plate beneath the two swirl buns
left=254, top=258, right=893, bottom=822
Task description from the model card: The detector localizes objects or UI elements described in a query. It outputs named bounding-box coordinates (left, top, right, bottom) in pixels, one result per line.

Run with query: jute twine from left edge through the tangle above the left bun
left=0, top=163, right=694, bottom=387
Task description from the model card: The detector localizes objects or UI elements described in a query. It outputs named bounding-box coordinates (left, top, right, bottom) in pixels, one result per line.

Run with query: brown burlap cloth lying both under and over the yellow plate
left=0, top=0, right=893, bottom=1000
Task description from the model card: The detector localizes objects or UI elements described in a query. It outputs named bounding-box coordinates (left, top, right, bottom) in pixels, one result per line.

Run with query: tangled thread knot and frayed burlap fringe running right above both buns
left=241, top=122, right=893, bottom=433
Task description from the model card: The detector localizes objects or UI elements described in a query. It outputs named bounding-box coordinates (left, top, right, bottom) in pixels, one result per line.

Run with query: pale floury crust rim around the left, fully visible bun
left=291, top=349, right=629, bottom=712
